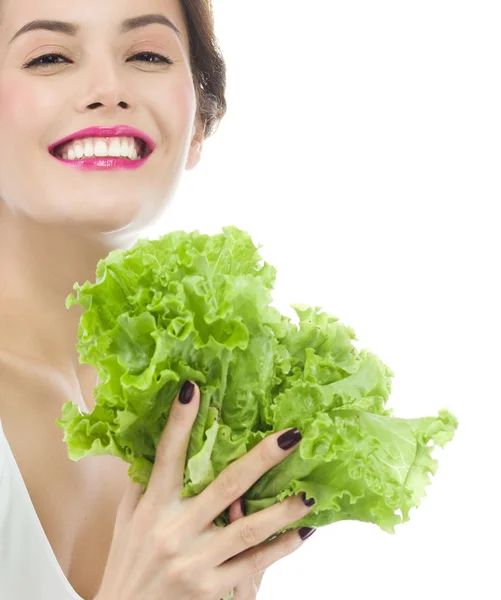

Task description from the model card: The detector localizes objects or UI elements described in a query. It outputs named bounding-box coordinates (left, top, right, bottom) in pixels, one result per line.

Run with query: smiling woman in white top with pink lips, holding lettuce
left=0, top=0, right=316, bottom=600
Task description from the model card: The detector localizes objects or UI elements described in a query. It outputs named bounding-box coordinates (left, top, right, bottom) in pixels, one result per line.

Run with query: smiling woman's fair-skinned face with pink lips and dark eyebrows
left=0, top=0, right=203, bottom=233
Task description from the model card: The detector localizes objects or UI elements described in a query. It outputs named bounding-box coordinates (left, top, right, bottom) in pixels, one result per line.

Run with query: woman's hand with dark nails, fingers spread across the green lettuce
left=96, top=386, right=311, bottom=600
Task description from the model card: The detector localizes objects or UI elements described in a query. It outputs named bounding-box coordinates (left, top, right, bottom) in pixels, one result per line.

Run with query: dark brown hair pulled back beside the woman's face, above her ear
left=181, top=0, right=226, bottom=139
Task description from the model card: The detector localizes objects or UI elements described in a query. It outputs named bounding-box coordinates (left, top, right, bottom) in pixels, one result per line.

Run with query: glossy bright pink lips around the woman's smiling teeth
left=48, top=125, right=156, bottom=171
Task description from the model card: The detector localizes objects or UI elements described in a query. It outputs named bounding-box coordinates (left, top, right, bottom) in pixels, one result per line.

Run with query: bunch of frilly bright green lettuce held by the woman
left=56, top=227, right=458, bottom=533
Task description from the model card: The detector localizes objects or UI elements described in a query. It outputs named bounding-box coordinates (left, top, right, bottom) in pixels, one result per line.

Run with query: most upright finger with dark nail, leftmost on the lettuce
left=145, top=381, right=200, bottom=504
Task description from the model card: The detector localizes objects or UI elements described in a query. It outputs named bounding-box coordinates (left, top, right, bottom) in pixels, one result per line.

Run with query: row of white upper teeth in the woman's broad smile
left=57, top=137, right=145, bottom=160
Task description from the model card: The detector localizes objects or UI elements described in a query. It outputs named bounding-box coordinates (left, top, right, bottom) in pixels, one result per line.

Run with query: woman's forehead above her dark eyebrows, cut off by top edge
left=0, top=0, right=188, bottom=47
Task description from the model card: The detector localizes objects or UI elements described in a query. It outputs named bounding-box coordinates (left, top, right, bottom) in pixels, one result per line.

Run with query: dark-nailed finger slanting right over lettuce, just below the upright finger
left=192, top=429, right=300, bottom=529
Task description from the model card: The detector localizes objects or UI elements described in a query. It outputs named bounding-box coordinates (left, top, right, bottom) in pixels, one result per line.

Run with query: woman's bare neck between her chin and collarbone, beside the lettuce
left=0, top=200, right=135, bottom=399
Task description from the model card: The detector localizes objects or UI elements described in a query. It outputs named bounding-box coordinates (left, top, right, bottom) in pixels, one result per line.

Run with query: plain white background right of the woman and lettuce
left=143, top=0, right=501, bottom=600
